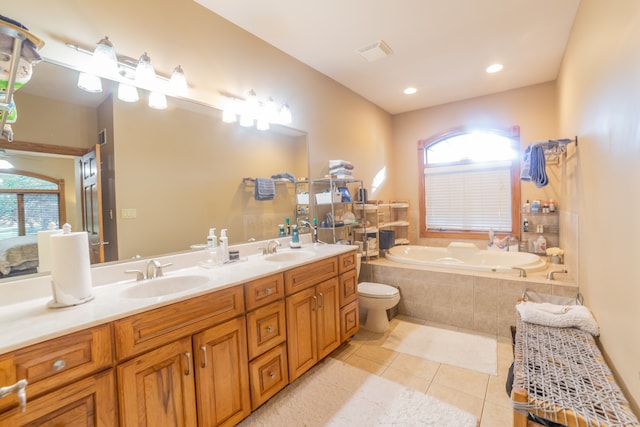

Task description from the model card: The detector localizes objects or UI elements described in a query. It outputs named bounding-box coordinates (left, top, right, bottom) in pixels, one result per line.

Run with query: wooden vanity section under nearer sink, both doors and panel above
left=115, top=286, right=251, bottom=426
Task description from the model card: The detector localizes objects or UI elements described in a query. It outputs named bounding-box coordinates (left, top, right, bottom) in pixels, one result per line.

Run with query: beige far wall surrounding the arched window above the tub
left=393, top=82, right=562, bottom=246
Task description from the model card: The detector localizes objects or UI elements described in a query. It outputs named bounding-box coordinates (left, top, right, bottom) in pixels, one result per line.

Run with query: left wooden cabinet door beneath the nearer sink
left=117, top=337, right=197, bottom=427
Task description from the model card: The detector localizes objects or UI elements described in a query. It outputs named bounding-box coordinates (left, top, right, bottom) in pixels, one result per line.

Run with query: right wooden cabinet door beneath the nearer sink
left=193, top=317, right=251, bottom=426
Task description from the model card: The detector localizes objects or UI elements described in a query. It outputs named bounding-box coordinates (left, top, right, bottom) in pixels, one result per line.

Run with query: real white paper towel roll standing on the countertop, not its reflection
left=49, top=231, right=93, bottom=307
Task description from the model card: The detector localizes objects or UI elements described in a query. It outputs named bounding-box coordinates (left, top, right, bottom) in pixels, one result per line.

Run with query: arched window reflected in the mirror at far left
left=0, top=170, right=66, bottom=239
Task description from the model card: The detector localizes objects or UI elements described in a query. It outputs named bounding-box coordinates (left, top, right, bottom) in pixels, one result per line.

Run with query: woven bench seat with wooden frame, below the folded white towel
left=511, top=320, right=640, bottom=427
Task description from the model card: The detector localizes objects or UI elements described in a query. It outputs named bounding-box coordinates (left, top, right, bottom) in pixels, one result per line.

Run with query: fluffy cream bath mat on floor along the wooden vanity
left=238, top=357, right=477, bottom=427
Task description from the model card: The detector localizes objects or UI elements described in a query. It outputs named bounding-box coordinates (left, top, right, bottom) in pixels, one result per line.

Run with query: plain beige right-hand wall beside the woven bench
left=558, top=0, right=640, bottom=411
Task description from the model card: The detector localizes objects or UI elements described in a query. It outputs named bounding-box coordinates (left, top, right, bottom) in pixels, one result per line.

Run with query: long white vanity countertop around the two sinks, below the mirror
left=0, top=239, right=356, bottom=354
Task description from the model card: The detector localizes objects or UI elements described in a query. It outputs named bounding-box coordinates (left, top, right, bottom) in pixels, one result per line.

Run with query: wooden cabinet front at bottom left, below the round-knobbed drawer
left=0, top=369, right=116, bottom=427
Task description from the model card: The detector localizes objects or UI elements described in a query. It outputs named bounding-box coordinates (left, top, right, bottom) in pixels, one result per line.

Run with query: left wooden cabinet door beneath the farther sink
left=286, top=288, right=318, bottom=382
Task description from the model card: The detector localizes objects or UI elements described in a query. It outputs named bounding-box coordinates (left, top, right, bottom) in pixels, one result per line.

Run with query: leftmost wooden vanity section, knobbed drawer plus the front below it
left=0, top=324, right=115, bottom=426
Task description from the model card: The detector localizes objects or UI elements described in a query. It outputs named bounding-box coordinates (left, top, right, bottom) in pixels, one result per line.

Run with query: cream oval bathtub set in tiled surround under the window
left=385, top=242, right=547, bottom=273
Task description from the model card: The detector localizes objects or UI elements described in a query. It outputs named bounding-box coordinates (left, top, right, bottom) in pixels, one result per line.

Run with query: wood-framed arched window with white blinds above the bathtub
left=418, top=127, right=520, bottom=239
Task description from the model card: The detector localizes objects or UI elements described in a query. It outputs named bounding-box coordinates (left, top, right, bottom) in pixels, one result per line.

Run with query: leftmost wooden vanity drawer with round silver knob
left=0, top=324, right=113, bottom=411
